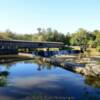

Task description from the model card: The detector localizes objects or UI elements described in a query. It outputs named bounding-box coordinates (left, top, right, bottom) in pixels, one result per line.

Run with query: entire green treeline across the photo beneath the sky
left=0, top=28, right=100, bottom=50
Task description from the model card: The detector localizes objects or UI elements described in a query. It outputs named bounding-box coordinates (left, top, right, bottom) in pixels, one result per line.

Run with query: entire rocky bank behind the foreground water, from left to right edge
left=0, top=53, right=100, bottom=78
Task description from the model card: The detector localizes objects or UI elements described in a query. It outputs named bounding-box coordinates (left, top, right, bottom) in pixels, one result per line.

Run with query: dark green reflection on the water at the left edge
left=0, top=71, right=9, bottom=87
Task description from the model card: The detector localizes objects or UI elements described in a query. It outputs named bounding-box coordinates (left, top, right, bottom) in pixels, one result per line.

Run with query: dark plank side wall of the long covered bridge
left=0, top=40, right=63, bottom=49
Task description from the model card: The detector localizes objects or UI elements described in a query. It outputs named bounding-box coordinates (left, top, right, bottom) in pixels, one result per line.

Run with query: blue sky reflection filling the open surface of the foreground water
left=0, top=60, right=100, bottom=99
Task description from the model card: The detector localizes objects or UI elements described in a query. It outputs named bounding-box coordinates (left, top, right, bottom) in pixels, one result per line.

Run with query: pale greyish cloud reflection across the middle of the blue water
left=11, top=75, right=60, bottom=89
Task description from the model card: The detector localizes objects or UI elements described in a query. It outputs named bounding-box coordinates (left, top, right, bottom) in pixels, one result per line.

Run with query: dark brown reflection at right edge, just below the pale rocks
left=85, top=76, right=100, bottom=88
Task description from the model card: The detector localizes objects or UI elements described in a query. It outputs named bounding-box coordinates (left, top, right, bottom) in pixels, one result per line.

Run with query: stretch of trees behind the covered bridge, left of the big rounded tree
left=0, top=28, right=70, bottom=45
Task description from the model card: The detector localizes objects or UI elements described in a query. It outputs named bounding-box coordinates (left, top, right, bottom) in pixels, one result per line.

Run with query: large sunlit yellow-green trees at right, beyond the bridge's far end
left=70, top=28, right=100, bottom=51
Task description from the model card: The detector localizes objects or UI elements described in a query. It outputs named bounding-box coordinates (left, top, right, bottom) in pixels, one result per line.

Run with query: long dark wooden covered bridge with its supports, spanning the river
left=0, top=39, right=64, bottom=54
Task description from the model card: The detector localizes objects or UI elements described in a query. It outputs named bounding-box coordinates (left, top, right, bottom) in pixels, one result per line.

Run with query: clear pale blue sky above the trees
left=0, top=0, right=100, bottom=34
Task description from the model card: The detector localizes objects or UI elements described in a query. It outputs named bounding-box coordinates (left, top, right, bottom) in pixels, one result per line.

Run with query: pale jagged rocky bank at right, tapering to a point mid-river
left=44, top=57, right=100, bottom=78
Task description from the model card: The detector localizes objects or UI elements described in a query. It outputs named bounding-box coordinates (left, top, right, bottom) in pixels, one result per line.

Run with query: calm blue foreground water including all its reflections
left=0, top=60, right=100, bottom=100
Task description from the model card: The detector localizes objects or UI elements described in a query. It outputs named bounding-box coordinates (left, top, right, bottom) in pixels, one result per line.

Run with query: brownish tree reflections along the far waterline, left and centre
left=0, top=57, right=52, bottom=71
